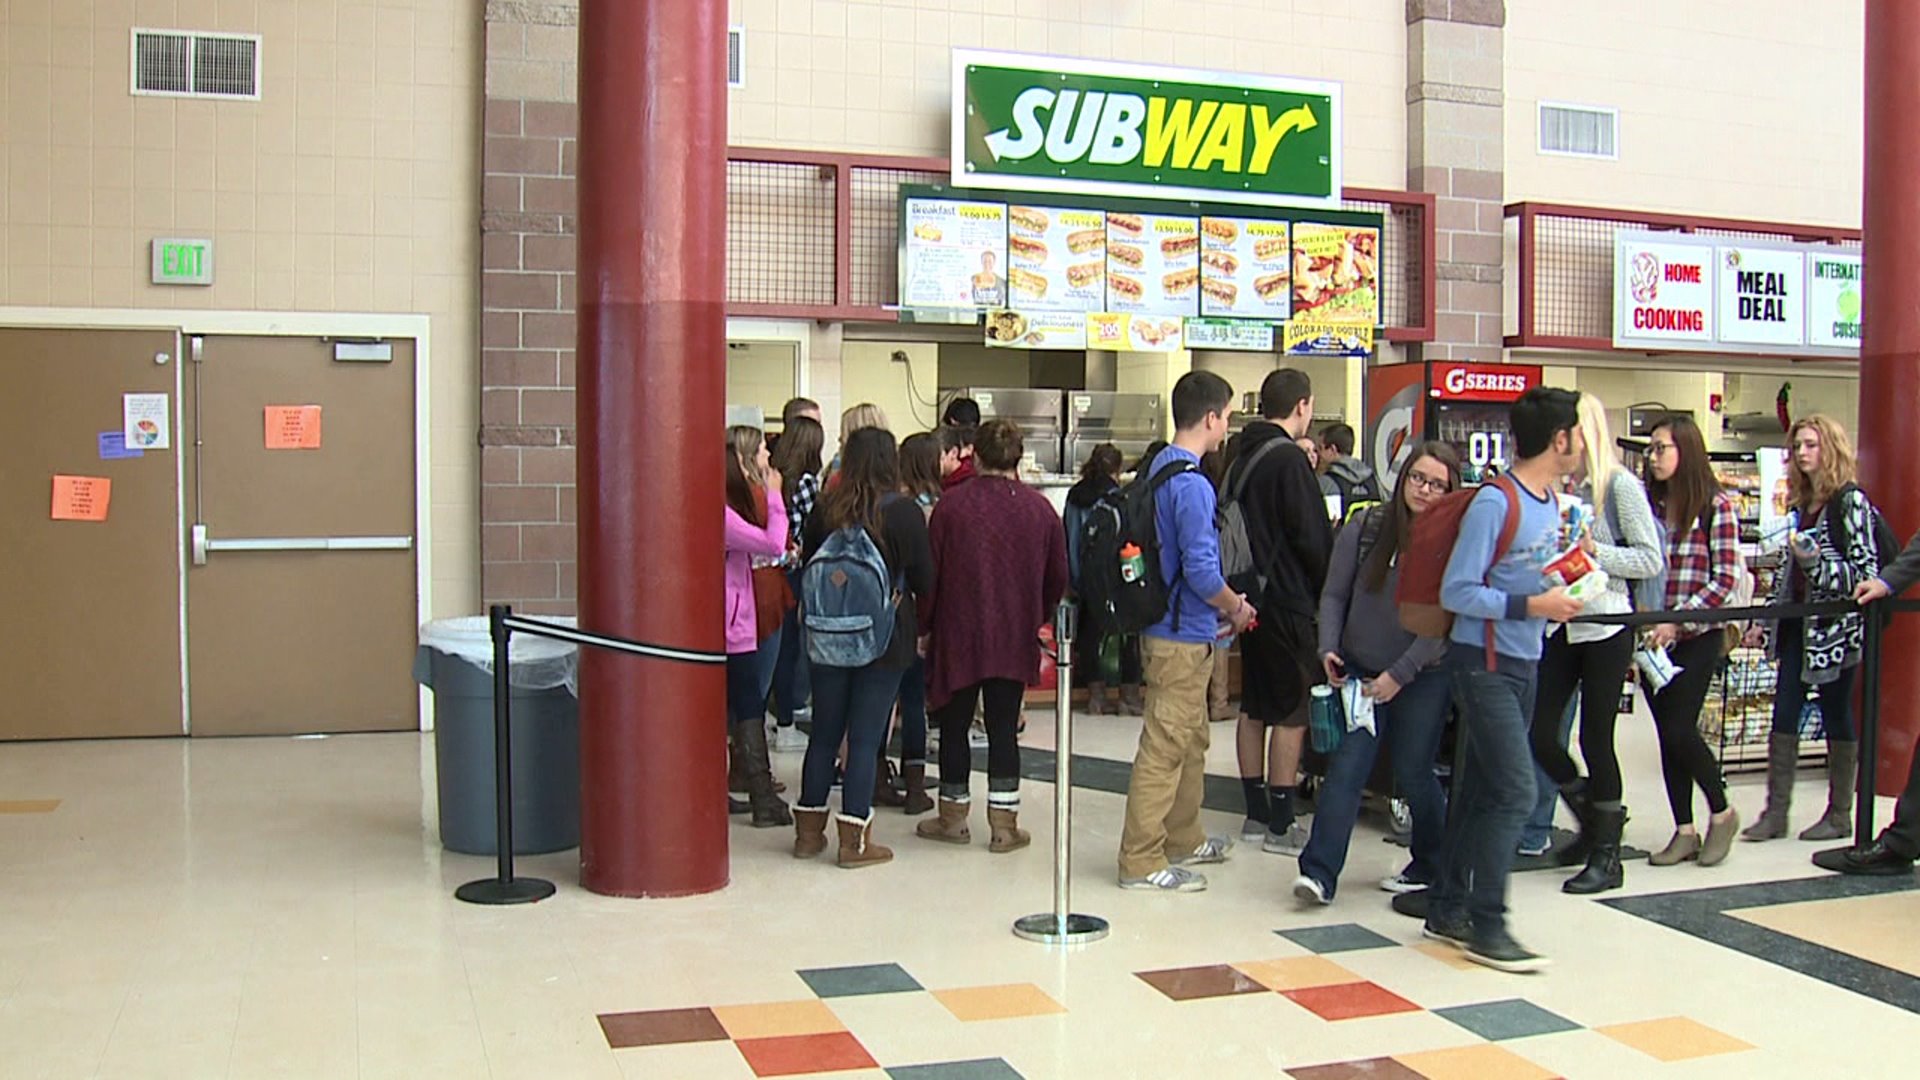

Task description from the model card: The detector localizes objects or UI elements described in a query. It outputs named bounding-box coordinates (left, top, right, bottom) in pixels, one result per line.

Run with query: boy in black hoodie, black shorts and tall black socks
left=1223, top=367, right=1332, bottom=855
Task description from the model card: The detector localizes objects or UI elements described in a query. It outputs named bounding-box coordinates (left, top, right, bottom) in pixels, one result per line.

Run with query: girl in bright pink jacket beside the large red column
left=726, top=427, right=793, bottom=828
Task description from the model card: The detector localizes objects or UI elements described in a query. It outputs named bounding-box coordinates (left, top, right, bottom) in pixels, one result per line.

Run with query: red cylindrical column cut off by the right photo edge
left=1860, top=0, right=1920, bottom=799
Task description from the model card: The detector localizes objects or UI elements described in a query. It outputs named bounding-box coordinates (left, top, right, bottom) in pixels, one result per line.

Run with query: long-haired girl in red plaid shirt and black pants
left=1647, top=417, right=1740, bottom=867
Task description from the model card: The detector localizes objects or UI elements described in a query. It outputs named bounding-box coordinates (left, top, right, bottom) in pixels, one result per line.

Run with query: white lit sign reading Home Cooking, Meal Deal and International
left=1613, top=233, right=1860, bottom=357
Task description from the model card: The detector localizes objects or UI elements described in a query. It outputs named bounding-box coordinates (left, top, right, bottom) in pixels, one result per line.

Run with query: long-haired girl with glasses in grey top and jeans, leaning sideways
left=1294, top=442, right=1459, bottom=905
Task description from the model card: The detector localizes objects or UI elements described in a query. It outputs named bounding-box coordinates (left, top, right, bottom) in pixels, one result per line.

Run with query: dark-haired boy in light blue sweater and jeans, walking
left=1425, top=386, right=1586, bottom=972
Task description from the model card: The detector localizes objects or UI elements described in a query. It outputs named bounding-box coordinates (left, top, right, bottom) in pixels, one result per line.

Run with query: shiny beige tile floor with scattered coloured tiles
left=0, top=713, right=1920, bottom=1080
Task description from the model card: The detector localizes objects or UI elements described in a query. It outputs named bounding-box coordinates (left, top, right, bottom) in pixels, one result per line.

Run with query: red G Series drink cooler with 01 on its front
left=1363, top=359, right=1540, bottom=488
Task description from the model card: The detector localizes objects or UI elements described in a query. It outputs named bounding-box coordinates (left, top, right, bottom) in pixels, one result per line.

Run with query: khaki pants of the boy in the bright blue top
left=1119, top=638, right=1213, bottom=878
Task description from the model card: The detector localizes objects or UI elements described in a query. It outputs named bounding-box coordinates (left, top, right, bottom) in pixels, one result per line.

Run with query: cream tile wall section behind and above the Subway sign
left=730, top=0, right=1407, bottom=188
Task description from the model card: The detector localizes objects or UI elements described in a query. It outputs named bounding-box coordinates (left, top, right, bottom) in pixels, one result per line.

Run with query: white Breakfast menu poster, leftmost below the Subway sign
left=900, top=198, right=1006, bottom=307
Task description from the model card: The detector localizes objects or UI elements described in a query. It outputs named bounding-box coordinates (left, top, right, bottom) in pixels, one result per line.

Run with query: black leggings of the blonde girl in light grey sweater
left=1532, top=628, right=1634, bottom=803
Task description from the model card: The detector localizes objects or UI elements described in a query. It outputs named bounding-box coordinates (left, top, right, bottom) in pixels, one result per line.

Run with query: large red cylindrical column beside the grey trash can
left=576, top=0, right=728, bottom=896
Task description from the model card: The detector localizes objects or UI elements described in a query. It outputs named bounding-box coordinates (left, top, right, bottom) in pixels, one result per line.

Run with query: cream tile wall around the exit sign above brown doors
left=0, top=0, right=482, bottom=613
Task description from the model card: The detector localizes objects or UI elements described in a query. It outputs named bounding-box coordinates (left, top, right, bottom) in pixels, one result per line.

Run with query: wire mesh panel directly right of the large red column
left=726, top=161, right=833, bottom=306
